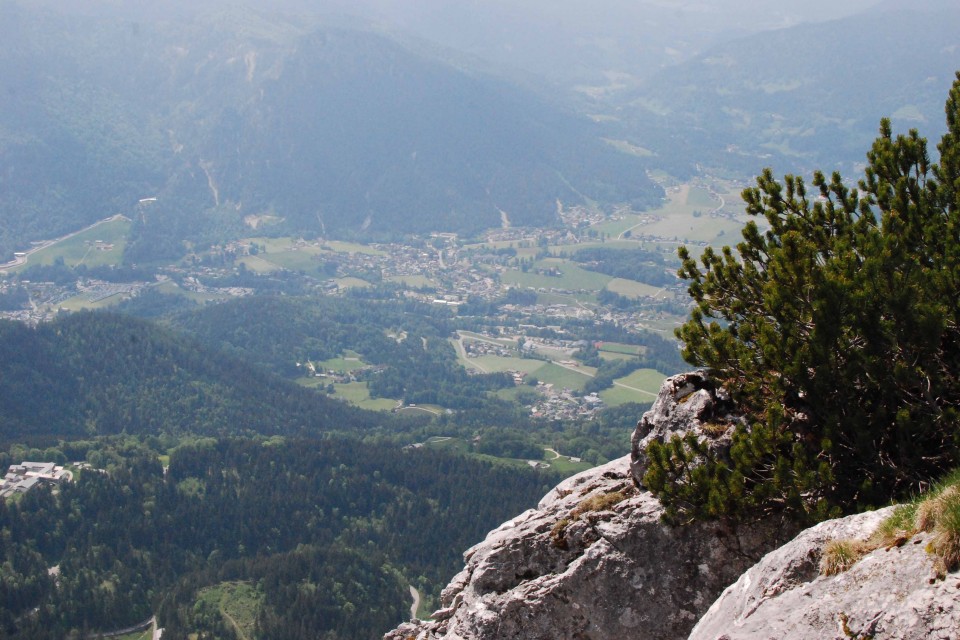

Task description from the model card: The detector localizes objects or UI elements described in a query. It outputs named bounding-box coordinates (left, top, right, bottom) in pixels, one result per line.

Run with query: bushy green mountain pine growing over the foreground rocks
left=644, top=73, right=960, bottom=519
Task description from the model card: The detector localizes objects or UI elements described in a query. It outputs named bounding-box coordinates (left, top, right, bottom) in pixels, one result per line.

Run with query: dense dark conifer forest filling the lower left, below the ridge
left=0, top=436, right=557, bottom=640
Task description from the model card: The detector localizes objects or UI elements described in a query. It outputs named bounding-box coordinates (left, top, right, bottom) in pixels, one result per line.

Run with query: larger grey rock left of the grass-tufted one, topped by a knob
left=386, top=374, right=792, bottom=640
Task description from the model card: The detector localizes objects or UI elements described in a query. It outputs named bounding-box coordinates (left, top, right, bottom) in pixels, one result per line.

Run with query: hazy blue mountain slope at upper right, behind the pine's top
left=621, top=2, right=960, bottom=174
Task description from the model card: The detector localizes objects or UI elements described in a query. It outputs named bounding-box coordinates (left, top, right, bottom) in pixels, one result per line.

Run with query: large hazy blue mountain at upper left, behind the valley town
left=0, top=2, right=661, bottom=260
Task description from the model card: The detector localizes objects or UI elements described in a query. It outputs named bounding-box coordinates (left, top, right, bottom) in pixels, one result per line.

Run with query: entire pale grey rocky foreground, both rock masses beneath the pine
left=385, top=373, right=960, bottom=640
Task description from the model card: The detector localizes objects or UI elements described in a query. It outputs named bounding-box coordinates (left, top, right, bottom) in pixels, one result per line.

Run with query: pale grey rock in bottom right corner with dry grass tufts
left=690, top=508, right=960, bottom=640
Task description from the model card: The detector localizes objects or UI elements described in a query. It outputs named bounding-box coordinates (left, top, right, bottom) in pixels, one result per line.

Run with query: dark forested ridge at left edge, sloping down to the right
left=0, top=313, right=386, bottom=440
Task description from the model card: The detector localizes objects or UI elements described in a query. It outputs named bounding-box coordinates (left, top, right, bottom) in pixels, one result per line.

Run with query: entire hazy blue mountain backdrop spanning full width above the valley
left=0, top=0, right=960, bottom=262
